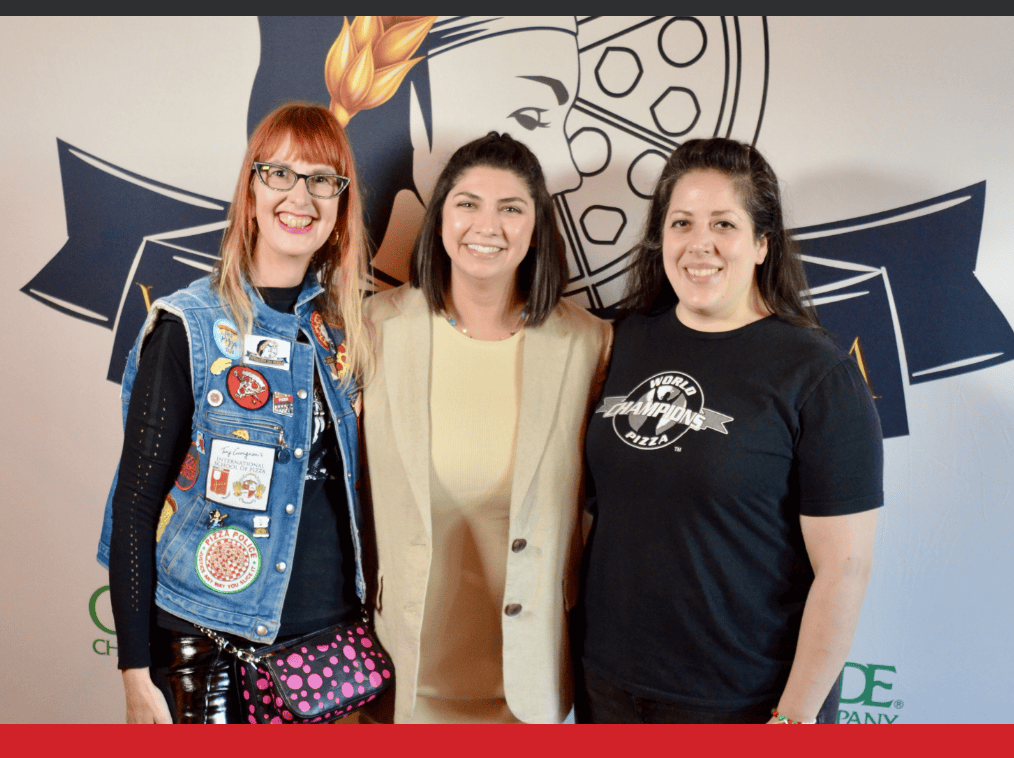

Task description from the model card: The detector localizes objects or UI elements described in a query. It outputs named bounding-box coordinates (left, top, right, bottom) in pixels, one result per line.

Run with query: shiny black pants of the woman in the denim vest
left=151, top=628, right=243, bottom=724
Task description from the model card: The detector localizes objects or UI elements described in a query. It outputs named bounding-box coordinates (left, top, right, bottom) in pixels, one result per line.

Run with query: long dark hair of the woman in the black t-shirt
left=617, top=137, right=821, bottom=329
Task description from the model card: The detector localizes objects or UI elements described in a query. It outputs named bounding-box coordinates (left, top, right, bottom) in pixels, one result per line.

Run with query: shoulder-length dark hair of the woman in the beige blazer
left=409, top=132, right=569, bottom=326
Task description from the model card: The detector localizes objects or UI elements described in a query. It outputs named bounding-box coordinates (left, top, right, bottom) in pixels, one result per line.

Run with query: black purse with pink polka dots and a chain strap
left=202, top=618, right=393, bottom=724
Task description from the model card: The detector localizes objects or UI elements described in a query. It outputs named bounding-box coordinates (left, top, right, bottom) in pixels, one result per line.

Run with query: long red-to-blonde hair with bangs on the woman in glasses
left=212, top=102, right=374, bottom=385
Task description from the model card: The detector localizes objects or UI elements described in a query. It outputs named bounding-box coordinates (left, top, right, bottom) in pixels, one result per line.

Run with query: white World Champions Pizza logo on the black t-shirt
left=595, top=371, right=732, bottom=450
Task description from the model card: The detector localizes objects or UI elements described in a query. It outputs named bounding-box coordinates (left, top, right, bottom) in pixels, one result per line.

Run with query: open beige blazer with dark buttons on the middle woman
left=362, top=285, right=612, bottom=724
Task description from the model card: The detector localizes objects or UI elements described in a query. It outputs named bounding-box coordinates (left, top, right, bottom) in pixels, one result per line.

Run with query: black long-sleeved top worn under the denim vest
left=110, top=285, right=359, bottom=669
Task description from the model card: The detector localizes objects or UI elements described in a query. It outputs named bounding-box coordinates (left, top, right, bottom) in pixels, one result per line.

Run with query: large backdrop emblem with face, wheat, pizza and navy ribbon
left=21, top=16, right=1014, bottom=438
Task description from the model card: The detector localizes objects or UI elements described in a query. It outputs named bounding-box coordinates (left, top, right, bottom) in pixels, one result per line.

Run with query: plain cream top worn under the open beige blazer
left=413, top=315, right=524, bottom=724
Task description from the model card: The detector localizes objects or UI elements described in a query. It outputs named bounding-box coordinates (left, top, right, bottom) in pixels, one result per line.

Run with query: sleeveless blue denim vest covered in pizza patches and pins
left=98, top=273, right=366, bottom=643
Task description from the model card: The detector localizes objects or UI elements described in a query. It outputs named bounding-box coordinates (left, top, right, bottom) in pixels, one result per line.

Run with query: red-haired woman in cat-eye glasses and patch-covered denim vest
left=98, top=103, right=372, bottom=723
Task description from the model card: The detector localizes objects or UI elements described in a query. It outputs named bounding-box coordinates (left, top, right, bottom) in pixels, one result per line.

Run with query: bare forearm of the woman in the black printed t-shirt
left=769, top=510, right=877, bottom=724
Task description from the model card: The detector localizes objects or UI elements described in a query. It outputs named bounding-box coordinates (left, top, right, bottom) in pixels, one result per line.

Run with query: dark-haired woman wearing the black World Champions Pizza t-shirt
left=576, top=139, right=883, bottom=724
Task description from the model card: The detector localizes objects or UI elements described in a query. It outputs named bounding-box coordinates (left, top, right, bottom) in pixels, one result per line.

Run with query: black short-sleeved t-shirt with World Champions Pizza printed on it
left=583, top=311, right=883, bottom=710
